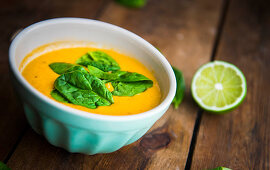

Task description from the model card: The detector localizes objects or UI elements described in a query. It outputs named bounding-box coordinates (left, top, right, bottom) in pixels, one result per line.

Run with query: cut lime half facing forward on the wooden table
left=191, top=61, right=247, bottom=113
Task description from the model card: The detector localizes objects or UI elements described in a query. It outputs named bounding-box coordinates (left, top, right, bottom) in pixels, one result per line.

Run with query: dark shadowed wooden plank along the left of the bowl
left=0, top=0, right=106, bottom=161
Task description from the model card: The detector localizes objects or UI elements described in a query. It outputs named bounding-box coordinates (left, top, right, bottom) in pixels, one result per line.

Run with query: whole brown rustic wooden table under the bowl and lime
left=0, top=0, right=270, bottom=170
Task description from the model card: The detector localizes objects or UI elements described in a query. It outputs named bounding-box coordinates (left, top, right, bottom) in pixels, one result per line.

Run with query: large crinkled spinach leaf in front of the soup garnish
left=54, top=71, right=113, bottom=109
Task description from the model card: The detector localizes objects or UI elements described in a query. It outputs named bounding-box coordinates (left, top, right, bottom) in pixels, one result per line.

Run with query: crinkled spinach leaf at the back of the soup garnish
left=76, top=51, right=120, bottom=72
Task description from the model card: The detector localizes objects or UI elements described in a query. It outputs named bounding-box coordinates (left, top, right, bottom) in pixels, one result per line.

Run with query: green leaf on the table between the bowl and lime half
left=172, top=67, right=186, bottom=109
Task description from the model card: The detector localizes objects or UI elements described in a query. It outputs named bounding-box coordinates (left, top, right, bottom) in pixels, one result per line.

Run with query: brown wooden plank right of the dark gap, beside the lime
left=192, top=0, right=270, bottom=170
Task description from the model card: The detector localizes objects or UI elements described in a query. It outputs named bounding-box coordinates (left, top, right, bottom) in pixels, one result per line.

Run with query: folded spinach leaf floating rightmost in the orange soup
left=88, top=66, right=153, bottom=96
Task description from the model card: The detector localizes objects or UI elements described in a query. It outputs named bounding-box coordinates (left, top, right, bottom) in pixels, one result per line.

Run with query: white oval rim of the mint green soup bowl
left=9, top=17, right=176, bottom=121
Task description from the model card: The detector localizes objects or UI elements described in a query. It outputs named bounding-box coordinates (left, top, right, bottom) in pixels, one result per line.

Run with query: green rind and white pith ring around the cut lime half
left=191, top=61, right=247, bottom=114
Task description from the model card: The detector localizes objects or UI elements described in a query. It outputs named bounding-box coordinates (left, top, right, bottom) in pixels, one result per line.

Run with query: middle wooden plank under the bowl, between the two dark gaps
left=8, top=0, right=221, bottom=169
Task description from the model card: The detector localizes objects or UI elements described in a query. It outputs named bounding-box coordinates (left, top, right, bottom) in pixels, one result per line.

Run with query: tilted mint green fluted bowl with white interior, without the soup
left=9, top=18, right=176, bottom=155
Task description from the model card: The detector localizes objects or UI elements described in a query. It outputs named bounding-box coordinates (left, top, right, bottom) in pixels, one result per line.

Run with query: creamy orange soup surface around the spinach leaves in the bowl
left=22, top=44, right=161, bottom=116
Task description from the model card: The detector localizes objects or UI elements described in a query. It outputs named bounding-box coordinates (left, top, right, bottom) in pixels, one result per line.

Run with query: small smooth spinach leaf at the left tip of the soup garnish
left=49, top=62, right=88, bottom=74
